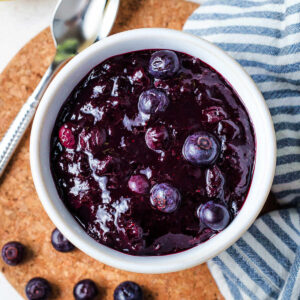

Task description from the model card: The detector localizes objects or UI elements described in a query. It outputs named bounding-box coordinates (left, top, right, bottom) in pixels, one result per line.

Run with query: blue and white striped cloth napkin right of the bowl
left=184, top=0, right=300, bottom=300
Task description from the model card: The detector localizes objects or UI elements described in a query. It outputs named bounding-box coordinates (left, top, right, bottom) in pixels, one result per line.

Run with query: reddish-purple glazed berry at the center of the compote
left=145, top=126, right=169, bottom=150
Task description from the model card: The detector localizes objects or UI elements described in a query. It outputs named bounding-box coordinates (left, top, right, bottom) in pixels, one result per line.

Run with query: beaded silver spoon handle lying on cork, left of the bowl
left=0, top=63, right=58, bottom=177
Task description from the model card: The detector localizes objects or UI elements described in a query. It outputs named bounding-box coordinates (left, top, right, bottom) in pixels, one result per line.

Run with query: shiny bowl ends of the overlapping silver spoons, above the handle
left=51, top=0, right=119, bottom=62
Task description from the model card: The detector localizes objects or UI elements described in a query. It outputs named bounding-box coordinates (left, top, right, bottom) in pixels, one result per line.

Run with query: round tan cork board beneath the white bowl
left=0, top=0, right=222, bottom=300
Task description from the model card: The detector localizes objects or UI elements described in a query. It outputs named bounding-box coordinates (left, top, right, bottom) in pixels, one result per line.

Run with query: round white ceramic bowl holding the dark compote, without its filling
left=30, top=29, right=276, bottom=273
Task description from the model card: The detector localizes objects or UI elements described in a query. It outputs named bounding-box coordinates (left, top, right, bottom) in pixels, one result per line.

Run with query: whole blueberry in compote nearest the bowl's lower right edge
left=198, top=201, right=230, bottom=230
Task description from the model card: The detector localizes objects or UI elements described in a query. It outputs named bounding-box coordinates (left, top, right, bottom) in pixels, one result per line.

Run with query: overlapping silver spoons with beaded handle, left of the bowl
left=0, top=0, right=120, bottom=176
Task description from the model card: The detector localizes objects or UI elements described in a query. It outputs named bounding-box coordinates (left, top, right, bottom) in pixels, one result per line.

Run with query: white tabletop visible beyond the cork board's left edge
left=0, top=0, right=57, bottom=300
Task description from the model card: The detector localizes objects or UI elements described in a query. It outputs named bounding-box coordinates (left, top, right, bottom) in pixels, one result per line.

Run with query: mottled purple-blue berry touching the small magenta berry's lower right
left=150, top=183, right=181, bottom=213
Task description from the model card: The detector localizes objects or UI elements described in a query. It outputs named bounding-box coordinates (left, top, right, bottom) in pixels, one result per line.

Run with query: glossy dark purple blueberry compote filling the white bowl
left=51, top=50, right=255, bottom=255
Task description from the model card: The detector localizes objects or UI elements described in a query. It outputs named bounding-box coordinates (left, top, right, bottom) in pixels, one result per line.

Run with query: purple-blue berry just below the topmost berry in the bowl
left=138, top=89, right=169, bottom=115
